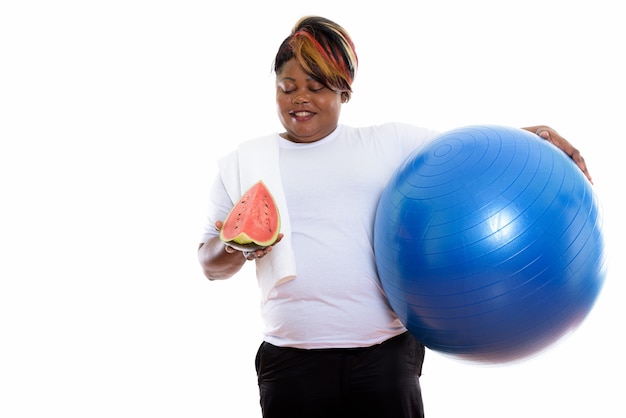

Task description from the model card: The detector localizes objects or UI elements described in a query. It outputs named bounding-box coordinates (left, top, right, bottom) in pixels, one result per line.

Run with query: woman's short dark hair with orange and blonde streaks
left=274, top=16, right=358, bottom=94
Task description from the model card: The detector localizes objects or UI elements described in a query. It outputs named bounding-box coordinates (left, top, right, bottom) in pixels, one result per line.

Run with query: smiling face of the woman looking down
left=276, top=59, right=341, bottom=142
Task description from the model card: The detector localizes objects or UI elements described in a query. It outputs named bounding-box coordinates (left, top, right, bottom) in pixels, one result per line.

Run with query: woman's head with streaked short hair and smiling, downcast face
left=274, top=17, right=358, bottom=142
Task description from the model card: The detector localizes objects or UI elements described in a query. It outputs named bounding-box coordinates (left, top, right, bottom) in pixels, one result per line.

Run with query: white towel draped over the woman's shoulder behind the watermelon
left=220, top=135, right=296, bottom=303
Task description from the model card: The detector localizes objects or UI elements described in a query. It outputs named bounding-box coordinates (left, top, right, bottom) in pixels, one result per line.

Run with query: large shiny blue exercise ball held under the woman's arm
left=374, top=125, right=606, bottom=363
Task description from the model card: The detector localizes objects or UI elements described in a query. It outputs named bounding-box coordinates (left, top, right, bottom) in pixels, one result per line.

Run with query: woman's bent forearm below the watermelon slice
left=198, top=237, right=246, bottom=280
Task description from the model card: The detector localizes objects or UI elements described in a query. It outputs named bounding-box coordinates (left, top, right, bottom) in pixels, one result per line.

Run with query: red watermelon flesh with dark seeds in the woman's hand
left=220, top=181, right=280, bottom=250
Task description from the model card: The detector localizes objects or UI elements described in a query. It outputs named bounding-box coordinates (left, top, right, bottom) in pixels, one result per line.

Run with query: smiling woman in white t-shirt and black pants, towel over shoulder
left=198, top=17, right=589, bottom=418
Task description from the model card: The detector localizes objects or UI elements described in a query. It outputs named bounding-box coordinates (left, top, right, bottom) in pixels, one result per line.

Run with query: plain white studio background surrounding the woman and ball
left=0, top=0, right=626, bottom=418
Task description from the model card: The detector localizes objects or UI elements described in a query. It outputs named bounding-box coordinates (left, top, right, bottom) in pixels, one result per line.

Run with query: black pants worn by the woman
left=256, top=333, right=424, bottom=418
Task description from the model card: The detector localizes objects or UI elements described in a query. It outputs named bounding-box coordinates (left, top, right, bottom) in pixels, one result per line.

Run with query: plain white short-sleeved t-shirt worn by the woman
left=202, top=123, right=437, bottom=349
